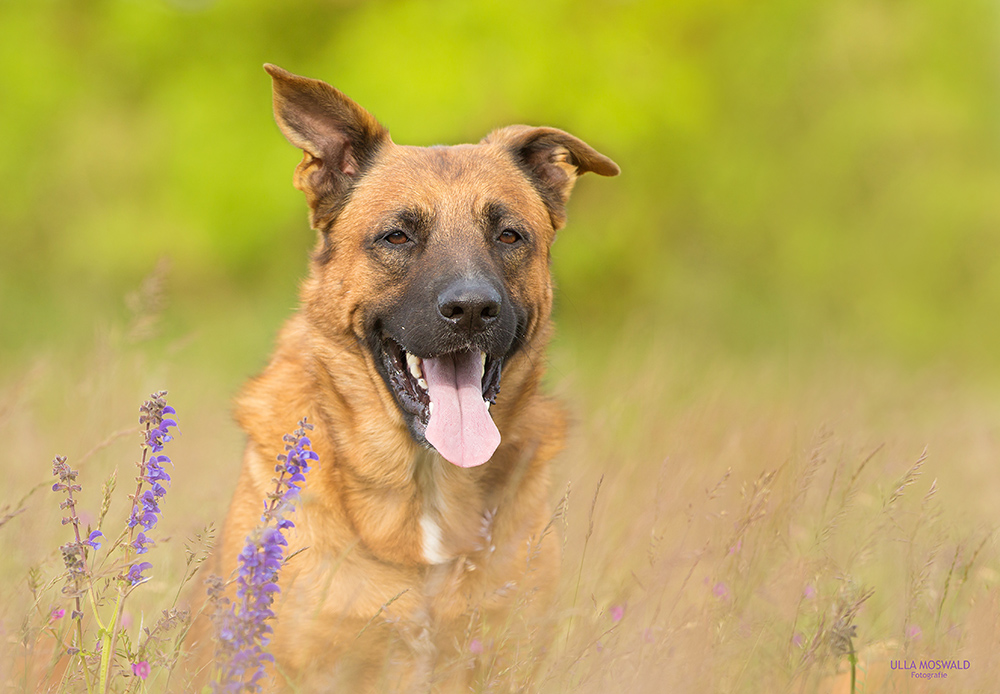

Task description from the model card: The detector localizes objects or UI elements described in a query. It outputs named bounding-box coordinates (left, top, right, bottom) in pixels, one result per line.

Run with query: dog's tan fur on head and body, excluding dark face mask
left=189, top=67, right=617, bottom=692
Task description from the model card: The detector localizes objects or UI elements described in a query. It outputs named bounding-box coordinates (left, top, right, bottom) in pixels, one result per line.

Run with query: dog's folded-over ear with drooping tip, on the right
left=483, top=125, right=621, bottom=229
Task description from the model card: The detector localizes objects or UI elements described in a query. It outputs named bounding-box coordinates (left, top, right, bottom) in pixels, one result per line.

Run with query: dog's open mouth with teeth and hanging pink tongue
left=383, top=338, right=502, bottom=467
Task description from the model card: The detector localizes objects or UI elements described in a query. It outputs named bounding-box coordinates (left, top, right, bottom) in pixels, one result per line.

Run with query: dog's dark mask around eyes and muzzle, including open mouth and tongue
left=367, top=207, right=532, bottom=467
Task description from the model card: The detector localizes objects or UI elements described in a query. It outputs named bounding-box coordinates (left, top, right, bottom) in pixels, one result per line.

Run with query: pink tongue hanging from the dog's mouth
left=423, top=350, right=500, bottom=467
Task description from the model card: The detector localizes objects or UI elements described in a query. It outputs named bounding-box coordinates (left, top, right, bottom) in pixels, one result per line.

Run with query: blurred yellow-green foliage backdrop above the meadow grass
left=0, top=0, right=1000, bottom=383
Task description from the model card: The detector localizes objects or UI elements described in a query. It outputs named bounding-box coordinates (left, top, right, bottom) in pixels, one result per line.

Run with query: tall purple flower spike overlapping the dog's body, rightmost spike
left=210, top=419, right=319, bottom=692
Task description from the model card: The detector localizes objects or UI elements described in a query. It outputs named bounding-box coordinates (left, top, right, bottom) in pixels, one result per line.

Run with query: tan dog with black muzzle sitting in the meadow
left=211, top=65, right=619, bottom=692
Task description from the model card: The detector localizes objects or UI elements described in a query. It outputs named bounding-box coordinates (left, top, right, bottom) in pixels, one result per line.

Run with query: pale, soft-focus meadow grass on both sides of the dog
left=0, top=294, right=1000, bottom=692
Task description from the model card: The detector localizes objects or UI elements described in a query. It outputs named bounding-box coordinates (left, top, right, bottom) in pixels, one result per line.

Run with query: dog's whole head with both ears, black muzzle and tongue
left=267, top=66, right=618, bottom=467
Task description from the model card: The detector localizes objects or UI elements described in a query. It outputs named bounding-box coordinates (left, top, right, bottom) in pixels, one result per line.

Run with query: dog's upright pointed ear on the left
left=264, top=64, right=389, bottom=229
